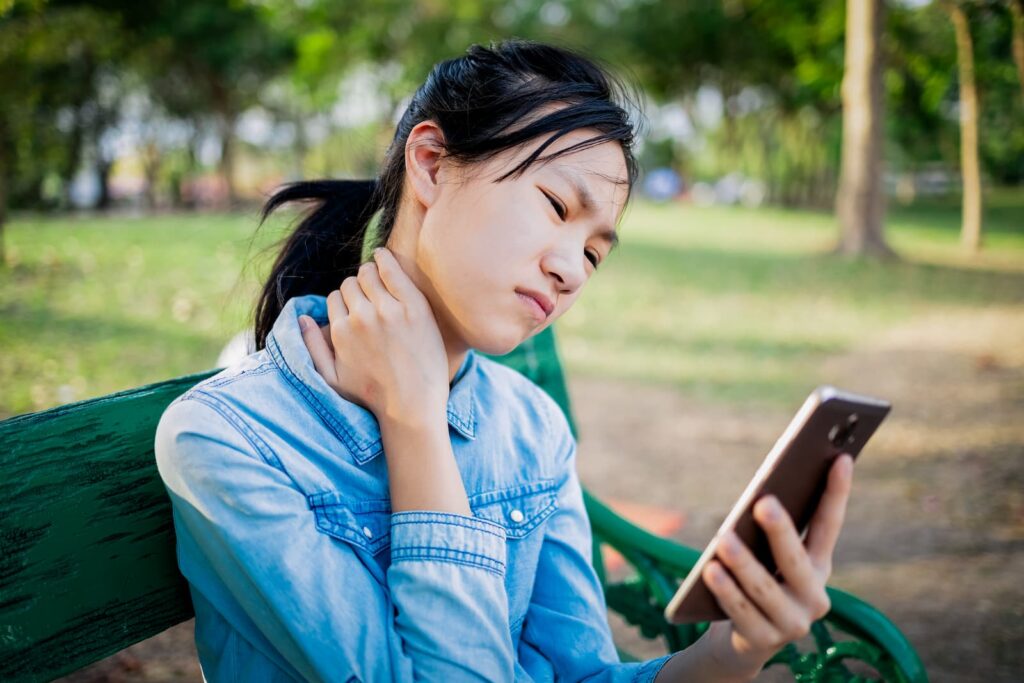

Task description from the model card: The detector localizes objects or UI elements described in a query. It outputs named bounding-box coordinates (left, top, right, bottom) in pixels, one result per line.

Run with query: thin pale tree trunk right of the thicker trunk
left=943, top=2, right=981, bottom=251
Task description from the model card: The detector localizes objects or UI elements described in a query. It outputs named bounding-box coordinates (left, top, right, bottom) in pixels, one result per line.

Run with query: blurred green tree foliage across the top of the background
left=0, top=0, right=1024, bottom=220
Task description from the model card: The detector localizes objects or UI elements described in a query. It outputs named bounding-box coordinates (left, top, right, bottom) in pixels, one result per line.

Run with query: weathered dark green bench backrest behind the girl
left=0, top=328, right=575, bottom=681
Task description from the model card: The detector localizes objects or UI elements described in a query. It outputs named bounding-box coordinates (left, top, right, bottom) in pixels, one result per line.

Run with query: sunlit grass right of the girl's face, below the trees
left=558, top=198, right=1024, bottom=404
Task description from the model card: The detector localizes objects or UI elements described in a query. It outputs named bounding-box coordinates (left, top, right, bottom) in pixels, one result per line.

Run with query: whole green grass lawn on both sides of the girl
left=0, top=191, right=1024, bottom=418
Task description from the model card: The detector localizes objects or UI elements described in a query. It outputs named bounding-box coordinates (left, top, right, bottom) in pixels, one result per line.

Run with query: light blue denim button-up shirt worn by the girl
left=156, top=295, right=668, bottom=683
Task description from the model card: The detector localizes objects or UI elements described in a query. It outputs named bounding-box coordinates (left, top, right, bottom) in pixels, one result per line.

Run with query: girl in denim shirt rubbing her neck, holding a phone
left=156, top=42, right=851, bottom=682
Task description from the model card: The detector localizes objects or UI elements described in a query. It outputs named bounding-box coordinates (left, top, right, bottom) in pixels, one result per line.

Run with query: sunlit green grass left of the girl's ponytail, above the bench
left=0, top=215, right=288, bottom=416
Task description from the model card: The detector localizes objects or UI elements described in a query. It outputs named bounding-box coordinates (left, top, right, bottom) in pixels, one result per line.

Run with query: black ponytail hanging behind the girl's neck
left=254, top=180, right=379, bottom=349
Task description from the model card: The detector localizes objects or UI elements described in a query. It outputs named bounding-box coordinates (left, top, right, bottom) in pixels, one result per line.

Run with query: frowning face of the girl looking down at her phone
left=401, top=129, right=628, bottom=355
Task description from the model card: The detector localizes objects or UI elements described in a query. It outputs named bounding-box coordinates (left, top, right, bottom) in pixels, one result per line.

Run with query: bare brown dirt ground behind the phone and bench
left=59, top=309, right=1024, bottom=683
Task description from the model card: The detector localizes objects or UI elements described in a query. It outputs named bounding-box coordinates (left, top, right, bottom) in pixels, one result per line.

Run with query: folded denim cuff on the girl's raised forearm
left=391, top=510, right=505, bottom=577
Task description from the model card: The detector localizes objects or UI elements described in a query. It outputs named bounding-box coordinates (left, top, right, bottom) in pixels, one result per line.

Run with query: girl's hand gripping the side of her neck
left=299, top=248, right=449, bottom=423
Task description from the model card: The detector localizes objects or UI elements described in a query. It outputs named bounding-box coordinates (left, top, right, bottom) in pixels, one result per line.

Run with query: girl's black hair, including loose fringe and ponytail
left=254, top=39, right=639, bottom=349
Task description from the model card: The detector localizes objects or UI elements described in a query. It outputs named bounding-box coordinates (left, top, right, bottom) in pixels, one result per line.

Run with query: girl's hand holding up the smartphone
left=702, top=454, right=853, bottom=675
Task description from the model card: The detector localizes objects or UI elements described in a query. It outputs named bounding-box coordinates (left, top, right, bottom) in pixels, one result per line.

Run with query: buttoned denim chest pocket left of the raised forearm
left=309, top=493, right=391, bottom=555
